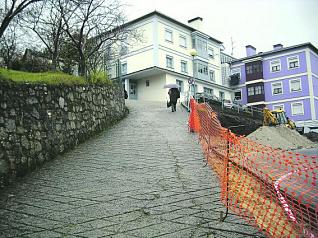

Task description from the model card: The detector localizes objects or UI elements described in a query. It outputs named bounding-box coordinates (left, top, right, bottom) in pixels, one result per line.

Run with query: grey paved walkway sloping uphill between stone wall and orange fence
left=0, top=99, right=261, bottom=238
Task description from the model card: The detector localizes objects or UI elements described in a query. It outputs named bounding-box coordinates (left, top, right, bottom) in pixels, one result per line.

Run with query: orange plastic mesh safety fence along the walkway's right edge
left=189, top=102, right=318, bottom=238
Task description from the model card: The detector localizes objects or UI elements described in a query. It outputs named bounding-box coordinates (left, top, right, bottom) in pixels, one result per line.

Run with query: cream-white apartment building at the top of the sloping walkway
left=110, top=11, right=232, bottom=101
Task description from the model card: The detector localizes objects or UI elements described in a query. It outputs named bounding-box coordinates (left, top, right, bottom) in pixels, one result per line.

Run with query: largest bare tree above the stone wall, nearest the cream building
left=58, top=0, right=137, bottom=77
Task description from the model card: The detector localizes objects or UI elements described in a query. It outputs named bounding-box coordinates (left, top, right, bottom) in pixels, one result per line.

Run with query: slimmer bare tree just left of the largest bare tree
left=25, top=0, right=65, bottom=70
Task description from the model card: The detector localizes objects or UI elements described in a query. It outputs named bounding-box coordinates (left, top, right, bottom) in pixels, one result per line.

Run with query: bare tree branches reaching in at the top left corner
left=0, top=0, right=44, bottom=38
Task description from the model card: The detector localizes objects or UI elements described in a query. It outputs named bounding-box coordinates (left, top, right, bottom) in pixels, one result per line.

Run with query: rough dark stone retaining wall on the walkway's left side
left=0, top=81, right=126, bottom=186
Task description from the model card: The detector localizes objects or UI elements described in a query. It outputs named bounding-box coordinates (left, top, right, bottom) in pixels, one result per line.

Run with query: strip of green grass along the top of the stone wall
left=0, top=68, right=110, bottom=85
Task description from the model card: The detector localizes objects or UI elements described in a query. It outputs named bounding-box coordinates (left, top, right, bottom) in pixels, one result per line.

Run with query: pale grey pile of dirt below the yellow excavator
left=247, top=126, right=317, bottom=150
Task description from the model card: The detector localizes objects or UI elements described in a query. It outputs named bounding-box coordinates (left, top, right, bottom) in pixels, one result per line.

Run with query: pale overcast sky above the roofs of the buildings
left=122, top=0, right=318, bottom=57
